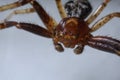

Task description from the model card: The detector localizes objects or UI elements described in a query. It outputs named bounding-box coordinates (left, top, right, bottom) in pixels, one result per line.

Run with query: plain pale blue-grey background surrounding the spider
left=0, top=0, right=120, bottom=80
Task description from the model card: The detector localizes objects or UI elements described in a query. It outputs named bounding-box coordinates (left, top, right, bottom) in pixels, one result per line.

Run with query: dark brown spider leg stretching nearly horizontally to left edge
left=0, top=21, right=52, bottom=38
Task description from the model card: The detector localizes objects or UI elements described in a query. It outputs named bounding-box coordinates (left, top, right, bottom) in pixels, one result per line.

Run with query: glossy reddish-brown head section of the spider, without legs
left=55, top=17, right=89, bottom=48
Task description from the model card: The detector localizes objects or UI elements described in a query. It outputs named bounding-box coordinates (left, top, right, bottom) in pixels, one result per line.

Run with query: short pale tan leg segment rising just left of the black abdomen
left=55, top=0, right=67, bottom=18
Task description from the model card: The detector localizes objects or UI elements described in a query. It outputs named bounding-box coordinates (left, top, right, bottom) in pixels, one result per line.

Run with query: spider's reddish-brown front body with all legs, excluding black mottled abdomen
left=0, top=0, right=120, bottom=55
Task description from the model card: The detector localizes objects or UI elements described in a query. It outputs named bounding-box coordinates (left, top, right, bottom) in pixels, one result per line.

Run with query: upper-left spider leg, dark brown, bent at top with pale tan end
left=0, top=0, right=57, bottom=32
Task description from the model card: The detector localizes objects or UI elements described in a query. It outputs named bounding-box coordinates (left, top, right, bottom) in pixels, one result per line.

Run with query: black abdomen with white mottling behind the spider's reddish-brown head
left=65, top=0, right=92, bottom=19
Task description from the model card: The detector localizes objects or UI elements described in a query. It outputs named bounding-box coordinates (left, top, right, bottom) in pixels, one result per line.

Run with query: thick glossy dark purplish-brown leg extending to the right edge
left=87, top=36, right=120, bottom=56
